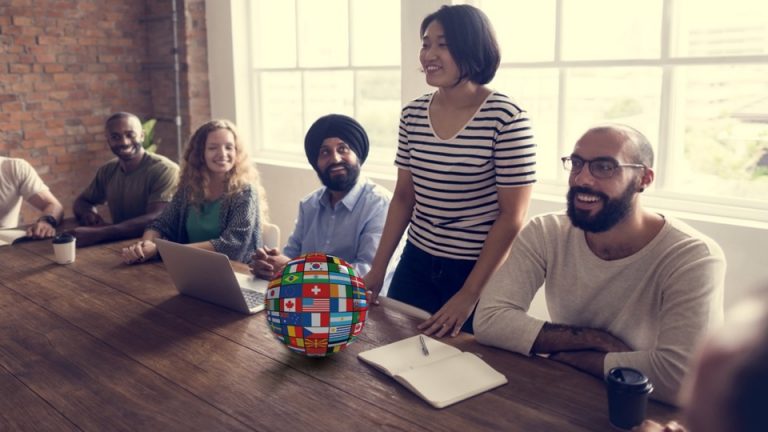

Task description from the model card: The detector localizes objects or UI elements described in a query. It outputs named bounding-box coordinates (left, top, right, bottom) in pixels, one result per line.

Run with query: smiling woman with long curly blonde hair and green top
left=123, top=120, right=266, bottom=264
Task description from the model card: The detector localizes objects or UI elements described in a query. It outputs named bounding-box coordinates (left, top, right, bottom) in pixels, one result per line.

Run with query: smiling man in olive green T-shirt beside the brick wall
left=71, top=112, right=179, bottom=246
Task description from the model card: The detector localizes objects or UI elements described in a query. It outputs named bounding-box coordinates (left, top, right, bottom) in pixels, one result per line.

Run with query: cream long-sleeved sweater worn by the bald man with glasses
left=474, top=214, right=725, bottom=403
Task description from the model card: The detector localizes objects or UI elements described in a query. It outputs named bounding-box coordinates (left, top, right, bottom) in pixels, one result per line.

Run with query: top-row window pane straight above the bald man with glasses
left=562, top=0, right=662, bottom=60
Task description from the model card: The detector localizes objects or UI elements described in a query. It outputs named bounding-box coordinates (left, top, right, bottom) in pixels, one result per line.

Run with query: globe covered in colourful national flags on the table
left=265, top=253, right=368, bottom=357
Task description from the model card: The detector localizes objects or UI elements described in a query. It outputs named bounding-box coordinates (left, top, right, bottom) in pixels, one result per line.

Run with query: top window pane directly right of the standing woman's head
left=477, top=0, right=555, bottom=63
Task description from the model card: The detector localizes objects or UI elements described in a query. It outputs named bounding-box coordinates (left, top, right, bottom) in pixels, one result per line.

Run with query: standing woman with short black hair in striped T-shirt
left=365, top=5, right=536, bottom=337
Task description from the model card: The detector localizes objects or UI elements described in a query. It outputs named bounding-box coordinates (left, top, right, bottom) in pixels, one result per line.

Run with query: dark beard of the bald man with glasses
left=568, top=183, right=637, bottom=233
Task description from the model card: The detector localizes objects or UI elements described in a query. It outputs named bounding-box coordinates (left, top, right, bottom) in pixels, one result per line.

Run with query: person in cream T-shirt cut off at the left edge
left=0, top=156, right=64, bottom=239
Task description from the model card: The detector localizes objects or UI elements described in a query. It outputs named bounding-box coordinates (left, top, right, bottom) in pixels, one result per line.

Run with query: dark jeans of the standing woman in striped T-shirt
left=387, top=241, right=476, bottom=333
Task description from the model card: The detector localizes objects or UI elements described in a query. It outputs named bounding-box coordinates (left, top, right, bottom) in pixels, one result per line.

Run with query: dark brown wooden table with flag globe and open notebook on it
left=0, top=240, right=674, bottom=431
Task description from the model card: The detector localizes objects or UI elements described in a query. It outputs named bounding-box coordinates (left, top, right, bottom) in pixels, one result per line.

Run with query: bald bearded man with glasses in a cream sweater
left=474, top=124, right=725, bottom=403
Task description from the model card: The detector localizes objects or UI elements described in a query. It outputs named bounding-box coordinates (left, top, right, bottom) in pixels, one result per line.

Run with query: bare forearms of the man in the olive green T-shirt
left=70, top=198, right=168, bottom=247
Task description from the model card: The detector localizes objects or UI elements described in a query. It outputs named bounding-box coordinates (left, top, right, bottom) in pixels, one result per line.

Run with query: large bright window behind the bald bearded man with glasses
left=476, top=0, right=768, bottom=218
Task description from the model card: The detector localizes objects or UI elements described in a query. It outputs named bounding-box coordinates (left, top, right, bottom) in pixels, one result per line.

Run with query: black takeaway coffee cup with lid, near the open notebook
left=605, top=367, right=653, bottom=429
